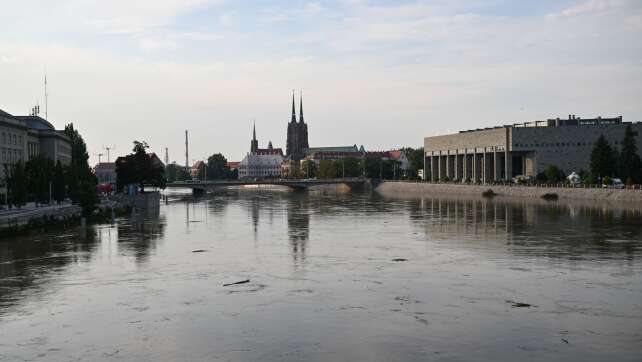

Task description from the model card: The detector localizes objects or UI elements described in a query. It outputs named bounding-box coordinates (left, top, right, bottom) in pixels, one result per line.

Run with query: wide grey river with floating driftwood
left=0, top=189, right=642, bottom=361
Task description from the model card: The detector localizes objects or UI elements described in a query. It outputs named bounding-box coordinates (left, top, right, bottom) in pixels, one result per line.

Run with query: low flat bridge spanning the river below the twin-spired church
left=166, top=177, right=368, bottom=194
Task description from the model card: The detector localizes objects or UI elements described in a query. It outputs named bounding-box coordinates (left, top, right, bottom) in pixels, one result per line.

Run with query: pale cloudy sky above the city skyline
left=0, top=0, right=642, bottom=164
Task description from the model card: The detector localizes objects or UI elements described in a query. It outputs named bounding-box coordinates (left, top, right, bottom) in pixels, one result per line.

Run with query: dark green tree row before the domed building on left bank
left=3, top=123, right=98, bottom=213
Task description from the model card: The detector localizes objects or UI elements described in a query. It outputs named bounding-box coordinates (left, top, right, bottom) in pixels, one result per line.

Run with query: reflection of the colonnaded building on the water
left=410, top=198, right=642, bottom=260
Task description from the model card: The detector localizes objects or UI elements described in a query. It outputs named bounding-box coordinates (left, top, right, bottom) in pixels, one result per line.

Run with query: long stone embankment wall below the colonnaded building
left=375, top=182, right=642, bottom=203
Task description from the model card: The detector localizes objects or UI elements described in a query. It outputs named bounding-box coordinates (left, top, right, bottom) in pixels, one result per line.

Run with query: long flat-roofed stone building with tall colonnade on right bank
left=424, top=115, right=642, bottom=183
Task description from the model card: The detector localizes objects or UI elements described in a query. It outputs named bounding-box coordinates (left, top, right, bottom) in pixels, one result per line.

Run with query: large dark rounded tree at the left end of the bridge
left=116, top=141, right=167, bottom=192
